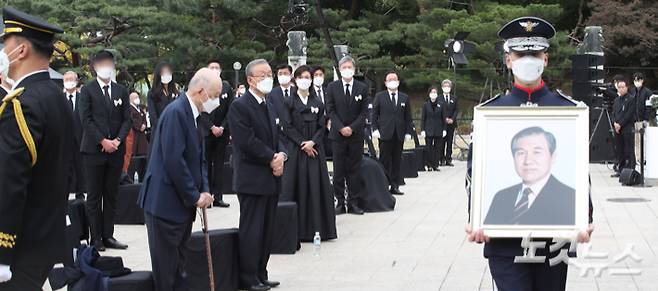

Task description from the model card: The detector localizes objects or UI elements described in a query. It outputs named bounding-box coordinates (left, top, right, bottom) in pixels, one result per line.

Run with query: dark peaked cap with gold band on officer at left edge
left=0, top=6, right=64, bottom=42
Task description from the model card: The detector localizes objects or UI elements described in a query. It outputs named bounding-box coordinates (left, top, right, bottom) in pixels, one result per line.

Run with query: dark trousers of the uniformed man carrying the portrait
left=489, top=256, right=567, bottom=291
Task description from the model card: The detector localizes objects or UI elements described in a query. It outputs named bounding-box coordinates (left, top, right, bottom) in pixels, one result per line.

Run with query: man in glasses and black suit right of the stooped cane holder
left=228, top=59, right=288, bottom=291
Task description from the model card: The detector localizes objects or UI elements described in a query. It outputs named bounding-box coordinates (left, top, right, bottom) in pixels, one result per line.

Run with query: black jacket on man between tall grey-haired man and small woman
left=372, top=90, right=413, bottom=141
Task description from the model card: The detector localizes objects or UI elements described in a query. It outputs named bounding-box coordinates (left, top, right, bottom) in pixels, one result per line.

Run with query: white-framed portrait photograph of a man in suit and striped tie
left=471, top=106, right=589, bottom=238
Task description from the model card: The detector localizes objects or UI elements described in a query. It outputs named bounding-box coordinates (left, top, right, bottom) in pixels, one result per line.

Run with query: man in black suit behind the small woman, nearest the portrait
left=439, top=79, right=457, bottom=167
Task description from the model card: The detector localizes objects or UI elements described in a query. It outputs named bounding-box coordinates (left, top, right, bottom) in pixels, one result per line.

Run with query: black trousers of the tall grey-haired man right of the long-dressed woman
left=332, top=138, right=363, bottom=205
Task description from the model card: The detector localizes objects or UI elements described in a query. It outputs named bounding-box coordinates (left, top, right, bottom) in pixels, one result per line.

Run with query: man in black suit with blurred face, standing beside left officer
left=80, top=50, right=131, bottom=251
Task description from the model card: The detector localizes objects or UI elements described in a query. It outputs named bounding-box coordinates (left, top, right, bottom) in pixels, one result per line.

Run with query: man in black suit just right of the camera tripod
left=612, top=75, right=637, bottom=177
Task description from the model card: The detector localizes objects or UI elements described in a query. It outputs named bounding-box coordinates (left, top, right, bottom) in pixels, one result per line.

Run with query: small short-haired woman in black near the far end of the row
left=420, top=86, right=444, bottom=171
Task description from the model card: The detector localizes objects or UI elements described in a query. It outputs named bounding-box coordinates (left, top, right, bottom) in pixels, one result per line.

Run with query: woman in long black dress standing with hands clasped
left=282, top=66, right=337, bottom=242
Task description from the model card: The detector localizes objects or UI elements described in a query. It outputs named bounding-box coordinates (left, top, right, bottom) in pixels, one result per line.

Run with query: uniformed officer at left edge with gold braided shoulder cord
left=0, top=7, right=73, bottom=291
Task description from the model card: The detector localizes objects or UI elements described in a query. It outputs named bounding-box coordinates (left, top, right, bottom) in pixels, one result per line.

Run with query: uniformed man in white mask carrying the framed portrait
left=466, top=17, right=594, bottom=291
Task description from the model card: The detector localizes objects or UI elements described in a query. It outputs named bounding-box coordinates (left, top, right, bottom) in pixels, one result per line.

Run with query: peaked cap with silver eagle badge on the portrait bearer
left=498, top=16, right=555, bottom=52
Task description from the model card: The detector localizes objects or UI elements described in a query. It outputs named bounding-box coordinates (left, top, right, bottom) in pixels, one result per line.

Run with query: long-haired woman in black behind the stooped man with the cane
left=146, top=62, right=178, bottom=129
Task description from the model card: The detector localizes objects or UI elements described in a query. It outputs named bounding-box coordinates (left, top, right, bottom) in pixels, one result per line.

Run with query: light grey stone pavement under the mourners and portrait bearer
left=46, top=162, right=658, bottom=291
